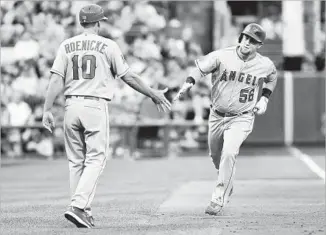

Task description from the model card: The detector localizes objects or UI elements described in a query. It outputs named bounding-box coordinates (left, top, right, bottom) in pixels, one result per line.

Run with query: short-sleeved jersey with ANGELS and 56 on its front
left=196, top=46, right=276, bottom=113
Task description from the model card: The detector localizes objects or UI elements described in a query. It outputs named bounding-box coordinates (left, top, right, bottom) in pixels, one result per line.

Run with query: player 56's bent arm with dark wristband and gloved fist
left=254, top=65, right=277, bottom=115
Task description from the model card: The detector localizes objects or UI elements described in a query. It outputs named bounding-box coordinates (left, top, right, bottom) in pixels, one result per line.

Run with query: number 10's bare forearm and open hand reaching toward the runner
left=121, top=70, right=171, bottom=112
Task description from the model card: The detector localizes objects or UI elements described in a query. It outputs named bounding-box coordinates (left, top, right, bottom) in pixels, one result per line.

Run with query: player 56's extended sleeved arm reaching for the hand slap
left=173, top=51, right=219, bottom=102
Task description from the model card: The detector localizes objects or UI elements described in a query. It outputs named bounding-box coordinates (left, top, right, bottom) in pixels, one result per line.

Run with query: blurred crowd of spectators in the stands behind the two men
left=0, top=1, right=325, bottom=157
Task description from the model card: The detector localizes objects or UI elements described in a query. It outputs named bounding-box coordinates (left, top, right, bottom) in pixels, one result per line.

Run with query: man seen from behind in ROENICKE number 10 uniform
left=43, top=4, right=171, bottom=228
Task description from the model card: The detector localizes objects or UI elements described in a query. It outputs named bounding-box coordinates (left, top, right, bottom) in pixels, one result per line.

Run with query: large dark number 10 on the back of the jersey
left=72, top=55, right=96, bottom=80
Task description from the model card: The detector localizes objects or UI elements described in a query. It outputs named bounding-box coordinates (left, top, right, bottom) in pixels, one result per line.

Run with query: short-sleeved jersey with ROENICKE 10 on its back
left=51, top=33, right=129, bottom=99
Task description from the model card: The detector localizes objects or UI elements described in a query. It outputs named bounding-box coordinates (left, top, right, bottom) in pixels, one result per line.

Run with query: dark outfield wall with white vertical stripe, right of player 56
left=245, top=72, right=325, bottom=144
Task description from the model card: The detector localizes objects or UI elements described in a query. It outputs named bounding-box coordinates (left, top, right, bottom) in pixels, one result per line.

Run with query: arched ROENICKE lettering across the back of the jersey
left=64, top=40, right=108, bottom=54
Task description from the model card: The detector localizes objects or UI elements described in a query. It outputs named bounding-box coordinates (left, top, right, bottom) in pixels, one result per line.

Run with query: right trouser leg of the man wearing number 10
left=71, top=100, right=109, bottom=210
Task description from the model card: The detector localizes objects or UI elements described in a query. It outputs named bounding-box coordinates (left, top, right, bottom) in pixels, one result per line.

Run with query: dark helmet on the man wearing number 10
left=79, top=4, right=108, bottom=23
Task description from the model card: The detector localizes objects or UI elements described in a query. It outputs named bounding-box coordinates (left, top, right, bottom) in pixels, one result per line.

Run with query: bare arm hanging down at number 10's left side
left=42, top=73, right=64, bottom=133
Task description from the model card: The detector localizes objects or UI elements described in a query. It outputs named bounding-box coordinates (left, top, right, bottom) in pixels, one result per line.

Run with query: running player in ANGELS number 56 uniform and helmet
left=173, top=23, right=277, bottom=215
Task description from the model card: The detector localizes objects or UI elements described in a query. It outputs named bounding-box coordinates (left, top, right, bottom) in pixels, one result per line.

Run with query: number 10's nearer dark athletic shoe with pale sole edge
left=65, top=206, right=93, bottom=228
